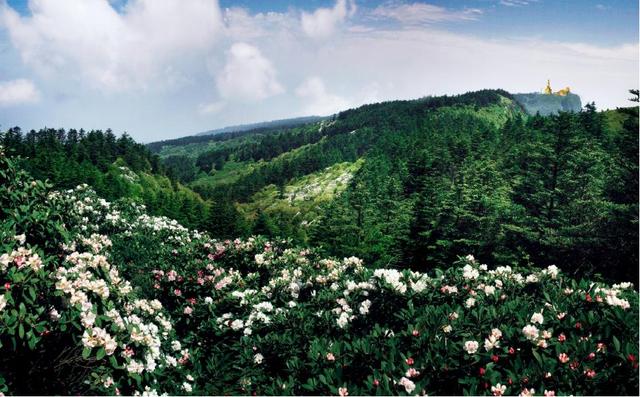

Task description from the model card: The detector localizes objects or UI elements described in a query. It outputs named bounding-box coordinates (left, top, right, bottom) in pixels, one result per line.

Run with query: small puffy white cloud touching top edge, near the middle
left=301, top=0, right=356, bottom=39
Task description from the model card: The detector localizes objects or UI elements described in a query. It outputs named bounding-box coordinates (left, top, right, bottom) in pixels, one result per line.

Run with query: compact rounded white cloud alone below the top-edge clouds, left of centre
left=216, top=43, right=284, bottom=101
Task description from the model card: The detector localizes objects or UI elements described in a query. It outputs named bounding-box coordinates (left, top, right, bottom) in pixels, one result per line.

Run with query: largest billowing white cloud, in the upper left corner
left=0, top=0, right=222, bottom=92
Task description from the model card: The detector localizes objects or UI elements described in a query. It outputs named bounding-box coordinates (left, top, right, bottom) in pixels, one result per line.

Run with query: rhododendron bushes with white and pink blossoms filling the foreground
left=0, top=148, right=638, bottom=396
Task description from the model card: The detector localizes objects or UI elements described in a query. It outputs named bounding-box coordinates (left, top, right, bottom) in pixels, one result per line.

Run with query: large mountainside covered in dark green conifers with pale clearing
left=153, top=90, right=638, bottom=279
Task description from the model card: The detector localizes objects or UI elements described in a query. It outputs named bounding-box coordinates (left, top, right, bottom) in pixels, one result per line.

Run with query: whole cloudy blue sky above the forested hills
left=0, top=0, right=638, bottom=142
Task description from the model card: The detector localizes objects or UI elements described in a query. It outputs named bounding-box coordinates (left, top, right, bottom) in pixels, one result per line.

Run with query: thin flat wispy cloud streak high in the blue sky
left=369, top=2, right=482, bottom=25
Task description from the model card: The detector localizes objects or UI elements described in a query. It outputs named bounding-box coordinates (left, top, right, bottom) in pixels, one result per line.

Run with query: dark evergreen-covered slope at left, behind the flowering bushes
left=0, top=127, right=209, bottom=228
